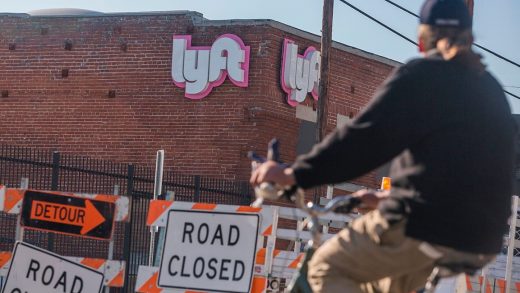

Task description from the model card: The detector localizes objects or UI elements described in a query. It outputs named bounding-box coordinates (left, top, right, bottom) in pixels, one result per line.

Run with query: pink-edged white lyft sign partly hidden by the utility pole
left=281, top=39, right=321, bottom=107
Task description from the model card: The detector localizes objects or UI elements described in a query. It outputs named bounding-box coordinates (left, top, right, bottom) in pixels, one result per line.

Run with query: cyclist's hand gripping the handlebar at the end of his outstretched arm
left=249, top=161, right=296, bottom=186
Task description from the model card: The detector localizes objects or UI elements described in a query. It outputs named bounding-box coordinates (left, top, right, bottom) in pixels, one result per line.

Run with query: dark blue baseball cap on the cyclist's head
left=420, top=0, right=472, bottom=28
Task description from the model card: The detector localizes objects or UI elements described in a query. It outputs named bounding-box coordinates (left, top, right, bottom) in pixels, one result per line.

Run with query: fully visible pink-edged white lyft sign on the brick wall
left=172, top=34, right=250, bottom=100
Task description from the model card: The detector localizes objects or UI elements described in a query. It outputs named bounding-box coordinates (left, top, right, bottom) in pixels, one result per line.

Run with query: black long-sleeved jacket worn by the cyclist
left=292, top=55, right=516, bottom=253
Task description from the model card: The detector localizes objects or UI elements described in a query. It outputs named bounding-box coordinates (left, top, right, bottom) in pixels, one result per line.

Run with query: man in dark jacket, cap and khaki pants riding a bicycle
left=251, top=0, right=516, bottom=293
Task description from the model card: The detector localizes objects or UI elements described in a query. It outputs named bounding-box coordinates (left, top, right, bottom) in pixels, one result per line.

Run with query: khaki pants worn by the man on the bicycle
left=308, top=210, right=494, bottom=293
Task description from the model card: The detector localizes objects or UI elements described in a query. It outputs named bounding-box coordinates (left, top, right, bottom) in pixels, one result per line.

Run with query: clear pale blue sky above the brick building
left=4, top=0, right=520, bottom=113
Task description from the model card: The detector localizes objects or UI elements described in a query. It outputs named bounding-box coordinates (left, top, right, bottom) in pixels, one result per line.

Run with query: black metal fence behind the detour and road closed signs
left=0, top=145, right=252, bottom=292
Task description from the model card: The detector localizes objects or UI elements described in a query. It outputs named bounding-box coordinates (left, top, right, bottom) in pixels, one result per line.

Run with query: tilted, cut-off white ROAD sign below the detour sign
left=2, top=242, right=103, bottom=293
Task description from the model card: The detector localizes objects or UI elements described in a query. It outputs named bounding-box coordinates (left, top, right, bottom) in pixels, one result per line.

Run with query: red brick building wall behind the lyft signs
left=0, top=10, right=398, bottom=186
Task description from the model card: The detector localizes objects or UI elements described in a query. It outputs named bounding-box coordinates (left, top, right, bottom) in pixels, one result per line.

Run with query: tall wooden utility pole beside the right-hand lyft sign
left=316, top=0, right=334, bottom=142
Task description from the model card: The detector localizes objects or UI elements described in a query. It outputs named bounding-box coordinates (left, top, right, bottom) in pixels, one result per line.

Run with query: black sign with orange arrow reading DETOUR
left=21, top=190, right=115, bottom=239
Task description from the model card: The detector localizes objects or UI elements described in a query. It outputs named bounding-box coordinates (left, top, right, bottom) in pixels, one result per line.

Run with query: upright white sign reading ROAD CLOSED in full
left=157, top=209, right=259, bottom=293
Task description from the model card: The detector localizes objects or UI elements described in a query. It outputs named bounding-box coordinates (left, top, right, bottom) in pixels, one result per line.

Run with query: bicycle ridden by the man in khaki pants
left=248, top=139, right=480, bottom=293
